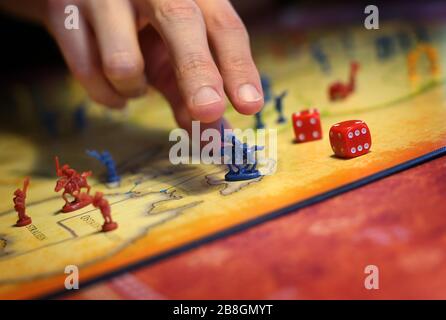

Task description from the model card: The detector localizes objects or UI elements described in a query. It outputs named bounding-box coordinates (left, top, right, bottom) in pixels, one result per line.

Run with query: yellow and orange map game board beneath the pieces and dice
left=0, top=16, right=446, bottom=298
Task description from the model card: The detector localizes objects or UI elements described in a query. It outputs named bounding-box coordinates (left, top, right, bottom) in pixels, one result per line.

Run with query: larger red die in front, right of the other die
left=330, top=120, right=372, bottom=158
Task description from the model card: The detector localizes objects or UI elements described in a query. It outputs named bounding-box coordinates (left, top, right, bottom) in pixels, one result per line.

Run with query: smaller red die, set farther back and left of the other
left=292, top=109, right=322, bottom=142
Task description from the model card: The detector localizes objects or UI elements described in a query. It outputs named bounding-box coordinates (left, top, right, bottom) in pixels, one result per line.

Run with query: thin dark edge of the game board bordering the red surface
left=42, top=146, right=446, bottom=299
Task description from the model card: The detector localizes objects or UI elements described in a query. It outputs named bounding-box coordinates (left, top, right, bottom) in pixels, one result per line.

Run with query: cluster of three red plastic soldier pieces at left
left=13, top=157, right=118, bottom=232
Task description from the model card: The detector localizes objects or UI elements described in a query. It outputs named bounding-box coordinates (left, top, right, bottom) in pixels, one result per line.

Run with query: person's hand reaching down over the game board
left=0, top=0, right=263, bottom=128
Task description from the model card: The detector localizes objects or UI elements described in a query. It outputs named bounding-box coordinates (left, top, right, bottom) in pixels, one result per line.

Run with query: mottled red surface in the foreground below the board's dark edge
left=64, top=157, right=446, bottom=299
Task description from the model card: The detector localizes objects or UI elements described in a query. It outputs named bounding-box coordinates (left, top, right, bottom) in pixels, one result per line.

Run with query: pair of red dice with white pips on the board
left=292, top=109, right=372, bottom=158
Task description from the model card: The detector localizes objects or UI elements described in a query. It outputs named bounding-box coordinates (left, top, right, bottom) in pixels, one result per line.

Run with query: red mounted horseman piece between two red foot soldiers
left=54, top=157, right=92, bottom=212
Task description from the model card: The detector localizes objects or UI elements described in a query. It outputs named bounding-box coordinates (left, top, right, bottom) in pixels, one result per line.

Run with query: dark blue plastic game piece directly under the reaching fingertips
left=221, top=126, right=264, bottom=181
